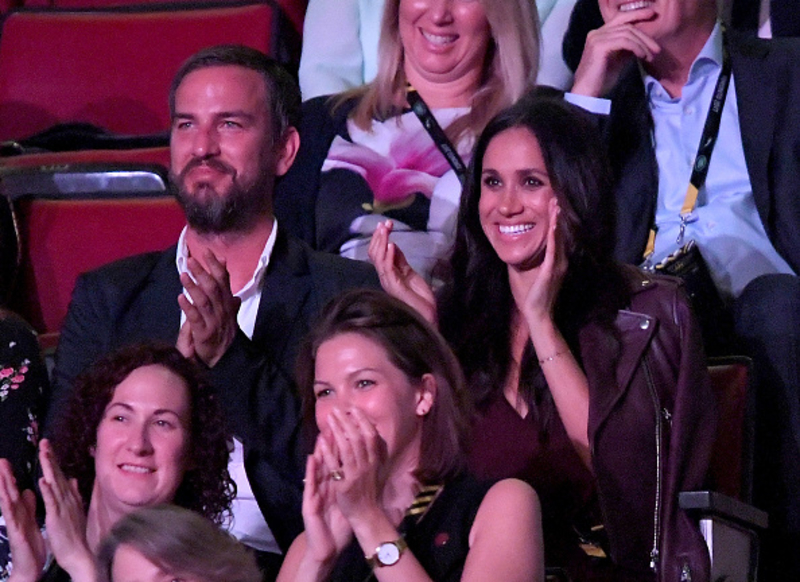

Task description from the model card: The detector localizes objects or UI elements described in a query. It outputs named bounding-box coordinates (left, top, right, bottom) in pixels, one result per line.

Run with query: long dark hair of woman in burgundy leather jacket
left=438, top=88, right=630, bottom=433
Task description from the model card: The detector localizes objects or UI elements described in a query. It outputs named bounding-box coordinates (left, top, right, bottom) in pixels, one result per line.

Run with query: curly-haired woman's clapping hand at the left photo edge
left=0, top=459, right=47, bottom=582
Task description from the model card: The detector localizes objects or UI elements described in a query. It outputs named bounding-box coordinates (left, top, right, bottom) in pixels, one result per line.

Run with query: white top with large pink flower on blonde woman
left=315, top=108, right=474, bottom=279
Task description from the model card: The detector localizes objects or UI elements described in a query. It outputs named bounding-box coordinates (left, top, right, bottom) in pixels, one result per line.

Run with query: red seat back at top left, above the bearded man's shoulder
left=0, top=3, right=274, bottom=141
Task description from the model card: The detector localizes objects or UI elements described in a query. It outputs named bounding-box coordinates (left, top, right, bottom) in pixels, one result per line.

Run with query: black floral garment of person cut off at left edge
left=0, top=310, right=48, bottom=580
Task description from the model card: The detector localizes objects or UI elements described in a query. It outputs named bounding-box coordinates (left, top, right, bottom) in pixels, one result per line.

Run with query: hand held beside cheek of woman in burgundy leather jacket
left=522, top=198, right=567, bottom=328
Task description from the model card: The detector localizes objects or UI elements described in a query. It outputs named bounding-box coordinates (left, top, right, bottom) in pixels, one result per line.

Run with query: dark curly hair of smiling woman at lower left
left=52, top=343, right=236, bottom=523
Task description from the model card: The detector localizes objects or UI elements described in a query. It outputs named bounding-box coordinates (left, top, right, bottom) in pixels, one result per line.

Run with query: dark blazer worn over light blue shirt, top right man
left=605, top=32, right=800, bottom=273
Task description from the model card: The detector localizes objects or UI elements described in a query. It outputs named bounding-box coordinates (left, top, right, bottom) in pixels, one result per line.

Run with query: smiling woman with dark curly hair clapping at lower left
left=0, top=345, right=233, bottom=582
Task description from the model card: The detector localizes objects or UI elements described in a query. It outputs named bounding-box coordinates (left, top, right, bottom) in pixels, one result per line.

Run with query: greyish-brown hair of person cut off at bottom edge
left=97, top=505, right=262, bottom=582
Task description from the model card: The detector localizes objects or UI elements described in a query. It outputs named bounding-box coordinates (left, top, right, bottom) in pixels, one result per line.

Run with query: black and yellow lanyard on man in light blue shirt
left=644, top=36, right=731, bottom=263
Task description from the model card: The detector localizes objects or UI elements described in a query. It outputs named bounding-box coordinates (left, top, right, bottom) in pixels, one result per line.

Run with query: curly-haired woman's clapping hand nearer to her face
left=39, top=439, right=95, bottom=582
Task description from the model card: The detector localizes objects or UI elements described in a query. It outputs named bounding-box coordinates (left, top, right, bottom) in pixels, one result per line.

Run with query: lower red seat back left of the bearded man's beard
left=13, top=197, right=185, bottom=332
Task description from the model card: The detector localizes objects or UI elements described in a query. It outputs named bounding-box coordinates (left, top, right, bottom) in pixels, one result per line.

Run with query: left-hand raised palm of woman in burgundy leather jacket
left=368, top=220, right=436, bottom=325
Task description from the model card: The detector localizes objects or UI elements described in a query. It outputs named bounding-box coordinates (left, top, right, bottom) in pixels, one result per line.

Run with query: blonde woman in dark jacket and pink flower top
left=275, top=0, right=539, bottom=277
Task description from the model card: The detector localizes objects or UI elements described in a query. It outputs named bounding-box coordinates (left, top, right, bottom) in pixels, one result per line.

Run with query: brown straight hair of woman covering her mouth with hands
left=297, top=289, right=468, bottom=484
